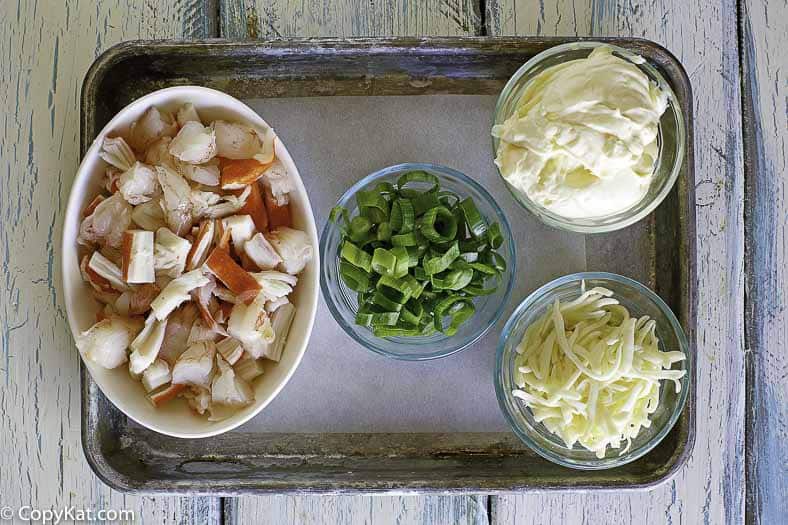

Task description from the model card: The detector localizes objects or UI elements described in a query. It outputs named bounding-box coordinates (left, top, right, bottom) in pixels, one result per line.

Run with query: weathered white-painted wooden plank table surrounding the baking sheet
left=0, top=0, right=788, bottom=524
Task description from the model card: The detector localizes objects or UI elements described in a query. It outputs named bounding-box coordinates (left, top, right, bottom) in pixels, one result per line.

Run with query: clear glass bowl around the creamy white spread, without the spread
left=492, top=42, right=686, bottom=233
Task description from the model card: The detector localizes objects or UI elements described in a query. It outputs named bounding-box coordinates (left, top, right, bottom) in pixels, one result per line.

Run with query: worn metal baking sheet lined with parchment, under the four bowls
left=81, top=38, right=696, bottom=494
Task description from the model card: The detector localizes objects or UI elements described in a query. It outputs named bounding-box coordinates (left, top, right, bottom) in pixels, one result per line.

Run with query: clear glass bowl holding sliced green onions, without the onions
left=320, top=163, right=516, bottom=361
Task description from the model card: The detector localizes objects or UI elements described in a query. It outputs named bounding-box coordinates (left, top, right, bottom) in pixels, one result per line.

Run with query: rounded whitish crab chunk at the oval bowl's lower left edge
left=76, top=317, right=142, bottom=368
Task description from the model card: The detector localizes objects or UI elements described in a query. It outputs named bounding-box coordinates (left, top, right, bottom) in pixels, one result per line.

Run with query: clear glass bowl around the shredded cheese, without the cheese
left=495, top=272, right=694, bottom=470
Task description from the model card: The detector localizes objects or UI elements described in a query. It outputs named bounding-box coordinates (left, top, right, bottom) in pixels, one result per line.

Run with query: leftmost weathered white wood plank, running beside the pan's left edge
left=0, top=0, right=220, bottom=523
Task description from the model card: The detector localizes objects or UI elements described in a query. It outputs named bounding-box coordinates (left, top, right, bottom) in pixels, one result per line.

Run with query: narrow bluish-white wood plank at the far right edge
left=741, top=0, right=788, bottom=524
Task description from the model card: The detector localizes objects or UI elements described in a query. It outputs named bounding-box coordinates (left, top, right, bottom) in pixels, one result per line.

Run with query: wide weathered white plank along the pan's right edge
left=486, top=0, right=744, bottom=524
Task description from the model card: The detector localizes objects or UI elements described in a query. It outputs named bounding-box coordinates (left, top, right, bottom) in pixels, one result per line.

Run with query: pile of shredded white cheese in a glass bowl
left=512, top=284, right=686, bottom=458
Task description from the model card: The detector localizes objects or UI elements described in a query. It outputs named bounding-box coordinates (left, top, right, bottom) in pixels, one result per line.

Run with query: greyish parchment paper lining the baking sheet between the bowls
left=243, top=95, right=586, bottom=432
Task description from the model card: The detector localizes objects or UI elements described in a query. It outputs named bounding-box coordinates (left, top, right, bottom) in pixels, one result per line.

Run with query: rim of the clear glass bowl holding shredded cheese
left=493, top=272, right=695, bottom=470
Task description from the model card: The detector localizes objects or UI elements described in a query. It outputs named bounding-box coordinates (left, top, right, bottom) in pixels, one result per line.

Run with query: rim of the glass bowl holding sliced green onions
left=320, top=162, right=517, bottom=361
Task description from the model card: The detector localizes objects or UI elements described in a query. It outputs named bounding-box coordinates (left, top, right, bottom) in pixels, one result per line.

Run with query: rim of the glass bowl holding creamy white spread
left=491, top=40, right=687, bottom=233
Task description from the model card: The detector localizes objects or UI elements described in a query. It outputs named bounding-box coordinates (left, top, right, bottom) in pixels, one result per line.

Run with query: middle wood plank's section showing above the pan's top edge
left=220, top=0, right=481, bottom=38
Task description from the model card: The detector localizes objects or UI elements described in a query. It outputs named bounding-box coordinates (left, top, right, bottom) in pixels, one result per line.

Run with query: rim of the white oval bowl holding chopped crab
left=60, top=85, right=320, bottom=439
